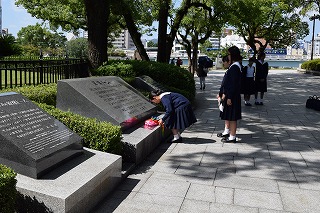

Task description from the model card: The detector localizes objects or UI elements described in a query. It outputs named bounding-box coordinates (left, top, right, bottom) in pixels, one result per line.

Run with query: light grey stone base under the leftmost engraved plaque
left=17, top=148, right=122, bottom=213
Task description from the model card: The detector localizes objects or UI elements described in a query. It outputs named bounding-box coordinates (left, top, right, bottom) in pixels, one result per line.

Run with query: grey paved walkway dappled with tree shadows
left=94, top=70, right=320, bottom=213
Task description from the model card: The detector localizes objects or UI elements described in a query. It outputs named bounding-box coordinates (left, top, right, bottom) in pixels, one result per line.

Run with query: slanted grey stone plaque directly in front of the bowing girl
left=57, top=76, right=156, bottom=130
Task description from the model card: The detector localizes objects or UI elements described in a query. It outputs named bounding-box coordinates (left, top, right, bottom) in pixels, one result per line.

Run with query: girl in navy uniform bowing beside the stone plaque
left=149, top=90, right=197, bottom=143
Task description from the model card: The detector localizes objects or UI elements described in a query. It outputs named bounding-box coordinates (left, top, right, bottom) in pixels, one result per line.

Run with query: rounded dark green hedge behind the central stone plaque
left=94, top=60, right=196, bottom=101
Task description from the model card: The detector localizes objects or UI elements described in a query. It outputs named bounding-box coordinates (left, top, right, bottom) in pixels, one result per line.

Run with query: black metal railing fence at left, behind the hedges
left=0, top=59, right=88, bottom=89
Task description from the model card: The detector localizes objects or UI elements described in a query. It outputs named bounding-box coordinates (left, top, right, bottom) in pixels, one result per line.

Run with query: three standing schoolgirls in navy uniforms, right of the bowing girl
left=217, top=46, right=269, bottom=143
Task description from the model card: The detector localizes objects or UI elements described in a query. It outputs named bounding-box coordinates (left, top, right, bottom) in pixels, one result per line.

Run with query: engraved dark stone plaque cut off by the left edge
left=0, top=92, right=83, bottom=178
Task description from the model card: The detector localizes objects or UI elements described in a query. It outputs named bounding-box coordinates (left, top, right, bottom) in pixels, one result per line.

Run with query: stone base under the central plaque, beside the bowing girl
left=122, top=118, right=172, bottom=164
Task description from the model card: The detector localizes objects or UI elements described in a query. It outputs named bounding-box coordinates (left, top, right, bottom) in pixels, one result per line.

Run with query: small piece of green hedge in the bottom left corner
left=0, top=164, right=17, bottom=213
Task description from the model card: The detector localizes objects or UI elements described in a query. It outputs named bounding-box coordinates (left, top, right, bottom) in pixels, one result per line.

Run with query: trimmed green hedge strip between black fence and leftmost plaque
left=0, top=83, right=57, bottom=106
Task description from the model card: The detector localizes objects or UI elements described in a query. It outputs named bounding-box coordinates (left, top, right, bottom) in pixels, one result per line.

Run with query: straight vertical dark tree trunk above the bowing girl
left=157, top=0, right=171, bottom=63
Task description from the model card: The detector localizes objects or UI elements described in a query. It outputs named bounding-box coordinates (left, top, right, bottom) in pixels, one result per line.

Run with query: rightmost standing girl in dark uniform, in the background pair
left=255, top=52, right=269, bottom=105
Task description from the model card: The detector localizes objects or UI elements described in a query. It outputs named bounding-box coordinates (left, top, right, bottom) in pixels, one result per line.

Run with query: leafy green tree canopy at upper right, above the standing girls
left=229, top=0, right=309, bottom=54
